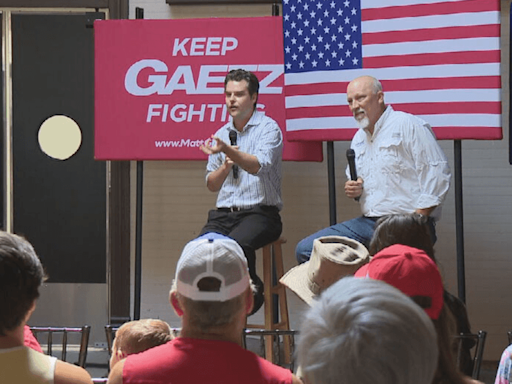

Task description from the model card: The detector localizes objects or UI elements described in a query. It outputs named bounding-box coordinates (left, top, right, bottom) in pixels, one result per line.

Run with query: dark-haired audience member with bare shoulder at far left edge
left=0, top=231, right=92, bottom=384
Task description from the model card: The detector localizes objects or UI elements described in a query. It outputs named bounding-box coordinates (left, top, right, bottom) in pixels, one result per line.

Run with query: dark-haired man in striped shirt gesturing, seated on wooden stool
left=200, top=69, right=283, bottom=313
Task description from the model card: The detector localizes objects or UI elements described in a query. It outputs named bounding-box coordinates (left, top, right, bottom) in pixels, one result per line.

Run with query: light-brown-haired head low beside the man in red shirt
left=110, top=319, right=173, bottom=369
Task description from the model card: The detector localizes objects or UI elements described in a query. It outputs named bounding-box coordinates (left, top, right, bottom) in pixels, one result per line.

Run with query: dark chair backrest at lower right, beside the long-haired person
left=455, top=331, right=487, bottom=380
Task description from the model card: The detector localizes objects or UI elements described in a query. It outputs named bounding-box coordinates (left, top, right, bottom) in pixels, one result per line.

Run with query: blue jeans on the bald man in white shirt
left=295, top=216, right=378, bottom=264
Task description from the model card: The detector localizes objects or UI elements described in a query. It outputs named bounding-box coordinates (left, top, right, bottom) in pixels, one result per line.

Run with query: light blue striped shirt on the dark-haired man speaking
left=206, top=111, right=283, bottom=209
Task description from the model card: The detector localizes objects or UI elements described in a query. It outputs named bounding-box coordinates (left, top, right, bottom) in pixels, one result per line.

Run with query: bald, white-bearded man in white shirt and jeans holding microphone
left=295, top=76, right=451, bottom=263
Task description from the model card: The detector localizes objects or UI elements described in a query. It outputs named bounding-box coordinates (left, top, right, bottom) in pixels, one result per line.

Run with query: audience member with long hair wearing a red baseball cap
left=355, top=244, right=480, bottom=384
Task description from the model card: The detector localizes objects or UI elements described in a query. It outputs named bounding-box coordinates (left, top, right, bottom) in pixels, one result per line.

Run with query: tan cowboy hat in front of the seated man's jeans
left=279, top=236, right=370, bottom=305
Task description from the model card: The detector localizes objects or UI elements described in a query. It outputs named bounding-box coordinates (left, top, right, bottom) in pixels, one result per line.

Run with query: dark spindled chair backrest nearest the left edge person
left=30, top=325, right=91, bottom=368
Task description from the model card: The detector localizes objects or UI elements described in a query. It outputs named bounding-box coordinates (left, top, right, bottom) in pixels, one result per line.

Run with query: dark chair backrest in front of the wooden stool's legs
left=242, top=329, right=299, bottom=372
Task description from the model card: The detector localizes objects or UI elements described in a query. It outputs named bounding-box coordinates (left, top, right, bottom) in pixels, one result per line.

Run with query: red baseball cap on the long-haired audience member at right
left=354, top=244, right=444, bottom=319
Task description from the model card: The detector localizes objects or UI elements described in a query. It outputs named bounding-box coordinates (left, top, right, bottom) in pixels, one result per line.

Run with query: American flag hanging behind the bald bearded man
left=283, top=0, right=502, bottom=140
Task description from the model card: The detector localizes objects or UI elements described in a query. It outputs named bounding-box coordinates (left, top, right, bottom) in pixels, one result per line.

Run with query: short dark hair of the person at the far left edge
left=0, top=231, right=45, bottom=336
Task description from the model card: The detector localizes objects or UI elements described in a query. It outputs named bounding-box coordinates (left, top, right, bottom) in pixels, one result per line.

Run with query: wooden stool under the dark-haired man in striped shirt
left=246, top=237, right=291, bottom=363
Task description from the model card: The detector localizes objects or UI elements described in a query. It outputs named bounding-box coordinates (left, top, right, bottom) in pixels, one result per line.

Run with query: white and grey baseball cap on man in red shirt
left=175, top=233, right=250, bottom=301
